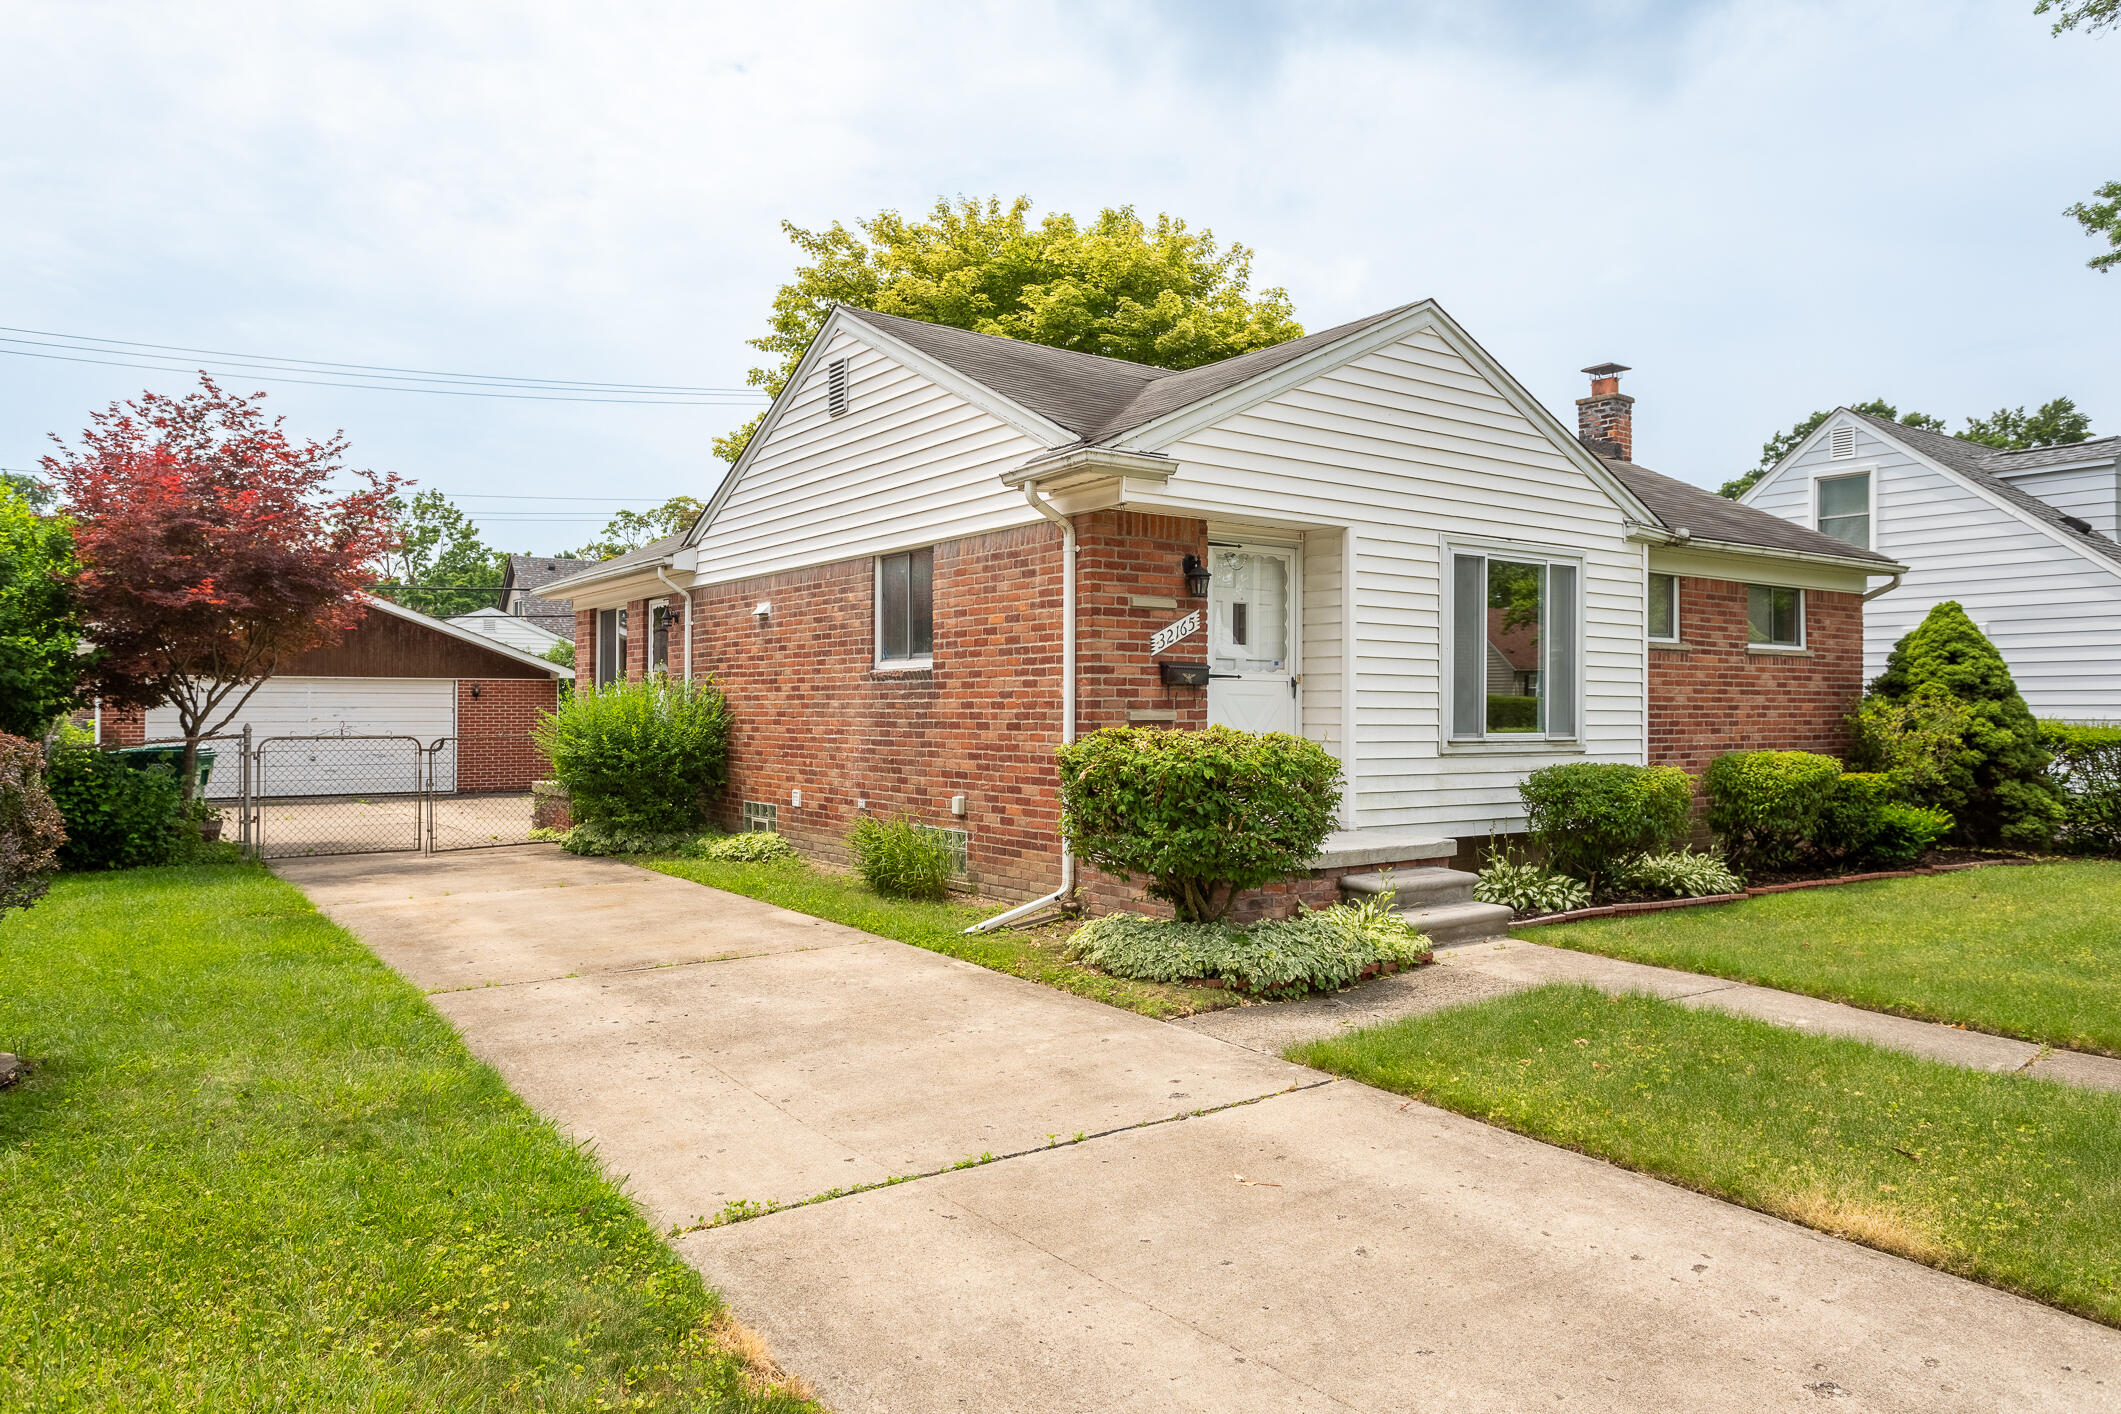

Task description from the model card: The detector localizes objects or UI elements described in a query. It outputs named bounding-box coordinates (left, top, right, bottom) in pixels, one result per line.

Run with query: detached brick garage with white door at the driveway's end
left=119, top=598, right=575, bottom=795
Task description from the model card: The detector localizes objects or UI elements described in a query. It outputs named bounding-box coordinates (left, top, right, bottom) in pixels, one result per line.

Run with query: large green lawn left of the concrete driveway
left=0, top=865, right=810, bottom=1414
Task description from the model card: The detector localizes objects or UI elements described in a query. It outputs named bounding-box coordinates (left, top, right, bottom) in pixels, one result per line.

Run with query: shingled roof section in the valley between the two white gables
left=840, top=305, right=1415, bottom=445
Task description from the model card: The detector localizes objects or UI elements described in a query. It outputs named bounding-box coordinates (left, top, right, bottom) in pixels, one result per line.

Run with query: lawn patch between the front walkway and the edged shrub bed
left=1529, top=863, right=2121, bottom=1056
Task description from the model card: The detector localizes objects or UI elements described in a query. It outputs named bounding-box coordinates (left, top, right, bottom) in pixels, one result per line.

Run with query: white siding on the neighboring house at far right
left=1746, top=415, right=2121, bottom=721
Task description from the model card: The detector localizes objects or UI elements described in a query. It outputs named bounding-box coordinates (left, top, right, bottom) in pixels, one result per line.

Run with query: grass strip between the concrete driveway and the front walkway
left=1290, top=983, right=2121, bottom=1325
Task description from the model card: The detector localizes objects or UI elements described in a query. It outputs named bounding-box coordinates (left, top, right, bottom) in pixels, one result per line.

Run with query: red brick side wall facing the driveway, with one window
left=691, top=524, right=1061, bottom=899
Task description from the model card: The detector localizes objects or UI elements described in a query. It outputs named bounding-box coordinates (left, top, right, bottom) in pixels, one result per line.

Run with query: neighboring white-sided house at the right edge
left=1743, top=407, right=2121, bottom=721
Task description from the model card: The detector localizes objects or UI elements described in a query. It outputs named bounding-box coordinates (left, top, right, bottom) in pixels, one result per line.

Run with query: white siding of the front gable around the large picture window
left=1130, top=331, right=1646, bottom=835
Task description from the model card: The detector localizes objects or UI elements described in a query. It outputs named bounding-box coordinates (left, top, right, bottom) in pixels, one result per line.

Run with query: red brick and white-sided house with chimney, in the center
left=541, top=301, right=1900, bottom=920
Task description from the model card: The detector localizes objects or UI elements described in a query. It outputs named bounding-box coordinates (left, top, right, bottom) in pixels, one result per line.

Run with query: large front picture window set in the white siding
left=1451, top=551, right=1582, bottom=740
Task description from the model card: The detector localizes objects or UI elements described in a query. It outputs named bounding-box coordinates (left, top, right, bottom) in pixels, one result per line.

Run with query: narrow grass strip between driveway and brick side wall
left=634, top=859, right=1237, bottom=1018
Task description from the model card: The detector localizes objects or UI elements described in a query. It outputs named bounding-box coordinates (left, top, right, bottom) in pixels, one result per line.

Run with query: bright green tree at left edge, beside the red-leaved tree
left=0, top=488, right=85, bottom=742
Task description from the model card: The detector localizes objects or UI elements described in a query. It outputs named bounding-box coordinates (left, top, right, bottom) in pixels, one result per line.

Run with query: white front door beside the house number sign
left=1207, top=545, right=1298, bottom=731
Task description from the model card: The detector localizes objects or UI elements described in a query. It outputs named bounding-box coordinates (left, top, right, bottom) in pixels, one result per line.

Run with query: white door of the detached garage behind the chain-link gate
left=146, top=678, right=456, bottom=795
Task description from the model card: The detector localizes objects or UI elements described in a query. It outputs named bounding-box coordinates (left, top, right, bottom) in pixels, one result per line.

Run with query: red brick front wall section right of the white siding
left=1650, top=579, right=1862, bottom=776
